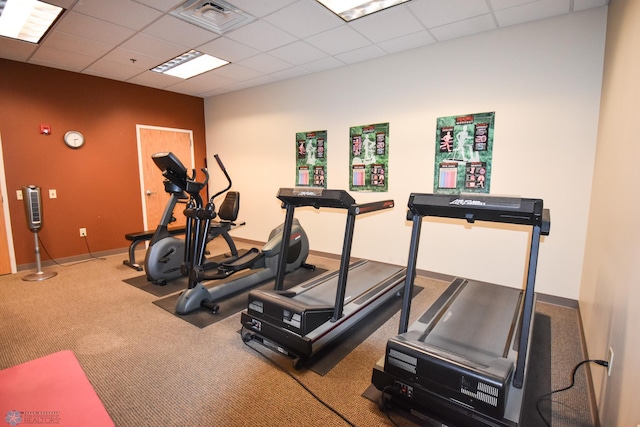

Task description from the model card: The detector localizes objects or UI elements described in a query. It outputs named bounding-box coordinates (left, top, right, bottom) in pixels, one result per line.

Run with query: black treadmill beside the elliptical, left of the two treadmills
left=241, top=187, right=406, bottom=368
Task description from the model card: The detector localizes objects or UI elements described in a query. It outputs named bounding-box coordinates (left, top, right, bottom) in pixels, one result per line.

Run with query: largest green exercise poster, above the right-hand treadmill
left=433, top=112, right=495, bottom=194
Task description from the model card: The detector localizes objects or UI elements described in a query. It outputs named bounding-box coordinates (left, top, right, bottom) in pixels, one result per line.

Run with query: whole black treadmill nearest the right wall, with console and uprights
left=372, top=193, right=550, bottom=427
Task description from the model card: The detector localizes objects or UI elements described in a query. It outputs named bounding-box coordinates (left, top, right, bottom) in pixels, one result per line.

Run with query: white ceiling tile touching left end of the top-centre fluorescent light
left=264, top=1, right=344, bottom=39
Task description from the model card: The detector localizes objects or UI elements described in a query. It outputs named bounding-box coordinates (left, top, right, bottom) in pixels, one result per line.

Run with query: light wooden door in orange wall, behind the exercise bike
left=136, top=125, right=194, bottom=234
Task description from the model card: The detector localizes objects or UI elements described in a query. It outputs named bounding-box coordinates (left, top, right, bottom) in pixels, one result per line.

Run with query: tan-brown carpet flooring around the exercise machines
left=0, top=242, right=593, bottom=427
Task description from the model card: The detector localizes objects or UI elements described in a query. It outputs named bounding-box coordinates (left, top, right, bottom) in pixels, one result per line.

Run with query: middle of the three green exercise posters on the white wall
left=349, top=123, right=389, bottom=191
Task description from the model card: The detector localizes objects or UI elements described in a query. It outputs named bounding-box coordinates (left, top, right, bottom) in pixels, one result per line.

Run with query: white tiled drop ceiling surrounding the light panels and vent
left=0, top=0, right=608, bottom=98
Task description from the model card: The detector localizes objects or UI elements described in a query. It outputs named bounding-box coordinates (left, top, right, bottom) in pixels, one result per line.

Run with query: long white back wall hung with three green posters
left=205, top=8, right=606, bottom=299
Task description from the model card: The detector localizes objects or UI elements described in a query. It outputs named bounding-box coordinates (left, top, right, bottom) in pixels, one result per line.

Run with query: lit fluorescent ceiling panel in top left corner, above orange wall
left=0, top=0, right=64, bottom=43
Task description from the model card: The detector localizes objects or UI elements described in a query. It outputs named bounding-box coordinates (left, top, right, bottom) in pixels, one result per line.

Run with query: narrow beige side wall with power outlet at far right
left=579, top=0, right=640, bottom=427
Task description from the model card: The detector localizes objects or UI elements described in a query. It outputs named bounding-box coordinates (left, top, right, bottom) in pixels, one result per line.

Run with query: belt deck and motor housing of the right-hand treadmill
left=372, top=278, right=523, bottom=427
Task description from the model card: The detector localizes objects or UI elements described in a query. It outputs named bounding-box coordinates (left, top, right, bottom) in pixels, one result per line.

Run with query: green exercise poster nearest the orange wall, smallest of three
left=296, top=130, right=327, bottom=188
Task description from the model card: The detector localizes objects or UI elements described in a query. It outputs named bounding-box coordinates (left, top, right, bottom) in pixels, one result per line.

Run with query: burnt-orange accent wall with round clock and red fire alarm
left=0, top=59, right=206, bottom=265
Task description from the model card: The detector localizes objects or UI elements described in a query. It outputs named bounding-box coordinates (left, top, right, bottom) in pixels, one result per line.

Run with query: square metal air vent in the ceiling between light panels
left=171, top=0, right=255, bottom=34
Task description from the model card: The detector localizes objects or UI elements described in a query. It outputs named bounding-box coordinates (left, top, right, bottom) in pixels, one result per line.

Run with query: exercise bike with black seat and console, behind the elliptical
left=144, top=152, right=240, bottom=285
